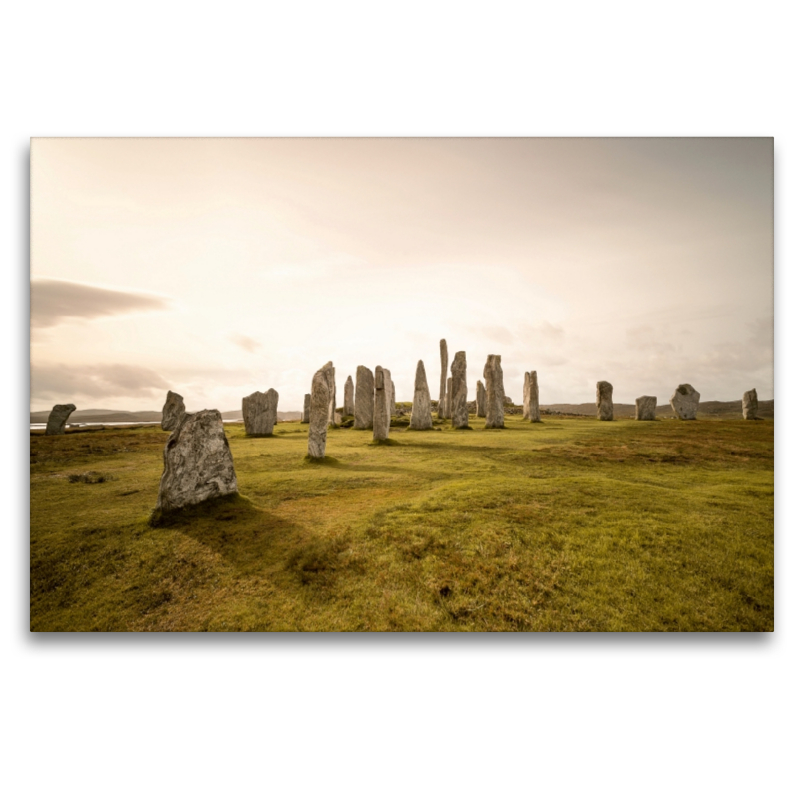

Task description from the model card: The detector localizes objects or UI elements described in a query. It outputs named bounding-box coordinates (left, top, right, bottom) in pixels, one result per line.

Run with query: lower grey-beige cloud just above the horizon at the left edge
left=31, top=364, right=170, bottom=403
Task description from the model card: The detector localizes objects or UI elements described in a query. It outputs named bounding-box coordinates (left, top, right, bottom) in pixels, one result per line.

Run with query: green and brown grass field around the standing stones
left=31, top=417, right=774, bottom=631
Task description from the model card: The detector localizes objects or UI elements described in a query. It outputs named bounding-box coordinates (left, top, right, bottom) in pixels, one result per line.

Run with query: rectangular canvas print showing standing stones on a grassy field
left=30, top=138, right=774, bottom=632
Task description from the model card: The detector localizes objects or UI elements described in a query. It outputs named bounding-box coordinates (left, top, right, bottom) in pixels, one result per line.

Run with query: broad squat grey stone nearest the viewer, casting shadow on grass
left=156, top=409, right=239, bottom=512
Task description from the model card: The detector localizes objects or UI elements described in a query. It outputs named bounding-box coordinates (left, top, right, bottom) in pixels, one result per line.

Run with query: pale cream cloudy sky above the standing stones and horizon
left=31, top=138, right=773, bottom=411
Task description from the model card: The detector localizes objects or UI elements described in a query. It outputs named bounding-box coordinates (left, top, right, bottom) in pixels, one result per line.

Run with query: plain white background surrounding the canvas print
left=0, top=2, right=800, bottom=798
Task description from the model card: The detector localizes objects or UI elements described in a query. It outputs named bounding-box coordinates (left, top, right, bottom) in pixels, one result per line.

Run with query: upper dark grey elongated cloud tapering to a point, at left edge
left=31, top=278, right=169, bottom=328
